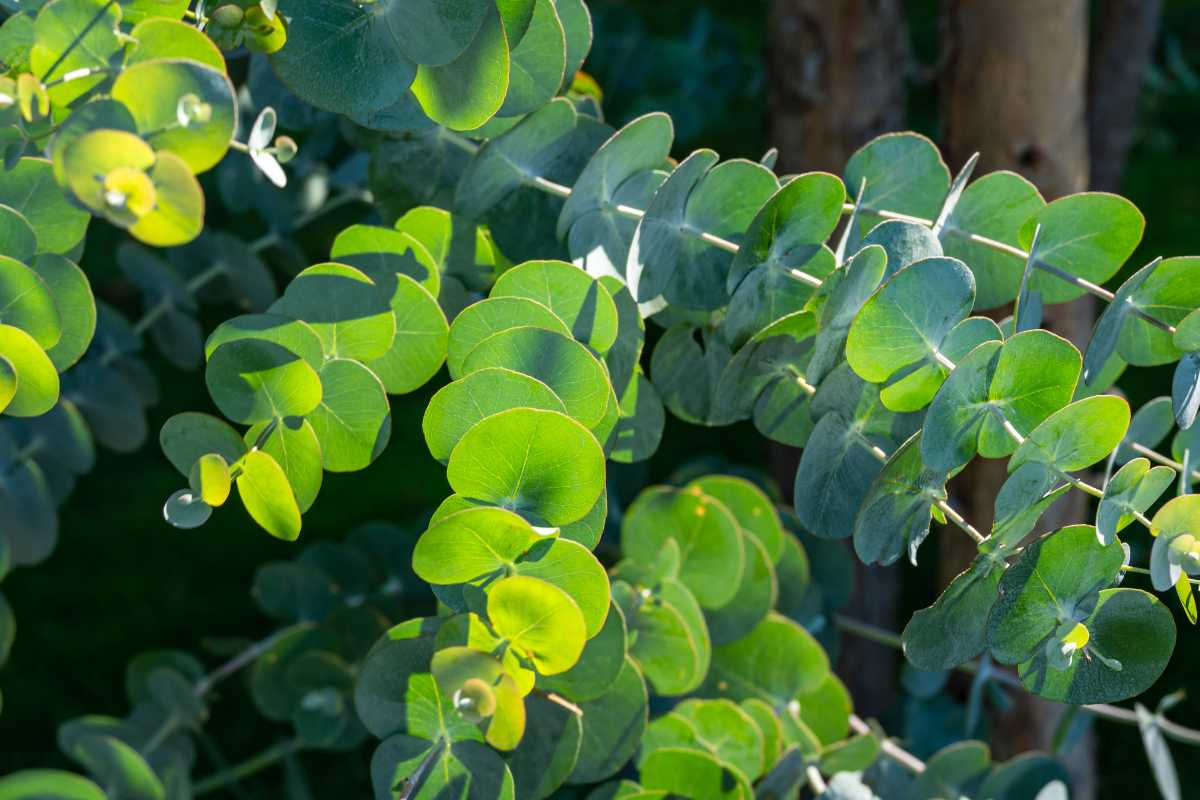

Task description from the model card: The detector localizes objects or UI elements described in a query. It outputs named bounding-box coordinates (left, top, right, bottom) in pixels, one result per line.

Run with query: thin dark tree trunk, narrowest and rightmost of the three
left=1087, top=0, right=1163, bottom=192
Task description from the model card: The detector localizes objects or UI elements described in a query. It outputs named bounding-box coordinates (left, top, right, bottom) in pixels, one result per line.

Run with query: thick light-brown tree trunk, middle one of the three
left=938, top=0, right=1096, bottom=798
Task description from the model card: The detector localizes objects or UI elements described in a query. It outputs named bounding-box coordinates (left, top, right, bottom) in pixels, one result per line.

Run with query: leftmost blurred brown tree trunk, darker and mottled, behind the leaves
left=768, top=0, right=907, bottom=716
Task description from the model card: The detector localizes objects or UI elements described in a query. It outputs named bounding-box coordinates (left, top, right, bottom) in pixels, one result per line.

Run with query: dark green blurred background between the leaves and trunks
left=0, top=0, right=1200, bottom=798
